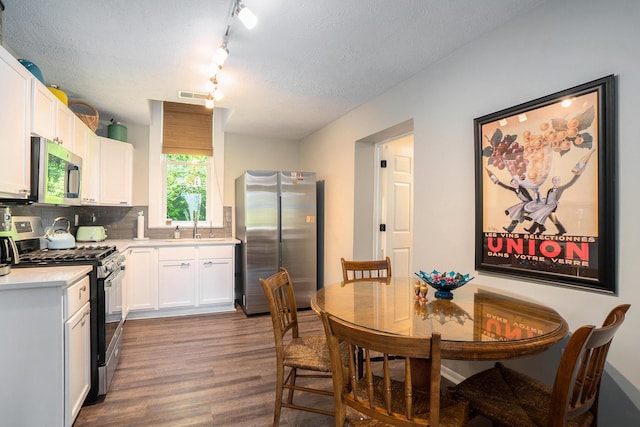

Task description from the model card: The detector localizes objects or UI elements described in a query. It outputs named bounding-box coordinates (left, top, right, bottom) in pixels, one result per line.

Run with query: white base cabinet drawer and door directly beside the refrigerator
left=198, top=246, right=234, bottom=305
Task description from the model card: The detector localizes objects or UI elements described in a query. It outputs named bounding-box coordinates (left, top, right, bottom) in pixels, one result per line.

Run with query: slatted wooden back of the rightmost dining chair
left=549, top=304, right=630, bottom=427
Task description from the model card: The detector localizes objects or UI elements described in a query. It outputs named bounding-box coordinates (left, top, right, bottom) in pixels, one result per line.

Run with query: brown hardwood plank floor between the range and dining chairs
left=74, top=309, right=334, bottom=427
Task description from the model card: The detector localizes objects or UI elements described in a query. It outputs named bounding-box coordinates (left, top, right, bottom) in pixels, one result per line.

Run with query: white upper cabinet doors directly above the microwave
left=31, top=78, right=76, bottom=152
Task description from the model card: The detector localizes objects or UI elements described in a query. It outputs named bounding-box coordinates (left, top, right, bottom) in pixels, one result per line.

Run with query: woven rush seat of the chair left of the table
left=284, top=335, right=331, bottom=372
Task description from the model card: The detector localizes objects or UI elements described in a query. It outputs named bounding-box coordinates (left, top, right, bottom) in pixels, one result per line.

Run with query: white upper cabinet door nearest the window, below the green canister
left=100, top=137, right=133, bottom=206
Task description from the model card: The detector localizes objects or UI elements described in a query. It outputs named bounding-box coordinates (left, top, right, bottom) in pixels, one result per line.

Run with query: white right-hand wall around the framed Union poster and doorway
left=301, top=0, right=640, bottom=425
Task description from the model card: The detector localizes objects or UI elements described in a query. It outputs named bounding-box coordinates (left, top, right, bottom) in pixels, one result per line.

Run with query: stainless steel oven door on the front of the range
left=98, top=266, right=124, bottom=395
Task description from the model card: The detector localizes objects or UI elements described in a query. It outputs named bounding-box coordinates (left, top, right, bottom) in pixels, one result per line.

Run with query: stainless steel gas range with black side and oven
left=12, top=216, right=125, bottom=404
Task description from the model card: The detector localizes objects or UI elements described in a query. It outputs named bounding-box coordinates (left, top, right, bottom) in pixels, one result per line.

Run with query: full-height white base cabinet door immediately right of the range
left=125, top=248, right=158, bottom=313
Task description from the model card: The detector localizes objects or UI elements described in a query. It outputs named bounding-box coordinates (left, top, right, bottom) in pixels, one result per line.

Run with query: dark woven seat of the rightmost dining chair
left=456, top=363, right=594, bottom=427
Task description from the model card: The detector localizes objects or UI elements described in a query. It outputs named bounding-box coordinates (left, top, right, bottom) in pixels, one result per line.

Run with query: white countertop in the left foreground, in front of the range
left=0, top=265, right=93, bottom=292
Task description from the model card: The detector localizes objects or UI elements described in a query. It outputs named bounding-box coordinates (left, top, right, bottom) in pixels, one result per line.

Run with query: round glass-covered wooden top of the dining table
left=311, top=277, right=569, bottom=360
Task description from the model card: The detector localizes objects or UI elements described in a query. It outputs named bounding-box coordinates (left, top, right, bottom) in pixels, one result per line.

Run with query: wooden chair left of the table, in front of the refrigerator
left=260, top=267, right=334, bottom=427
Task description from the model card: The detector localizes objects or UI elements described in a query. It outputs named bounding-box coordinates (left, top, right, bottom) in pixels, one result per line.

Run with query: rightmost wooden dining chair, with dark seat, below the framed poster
left=456, top=304, right=630, bottom=427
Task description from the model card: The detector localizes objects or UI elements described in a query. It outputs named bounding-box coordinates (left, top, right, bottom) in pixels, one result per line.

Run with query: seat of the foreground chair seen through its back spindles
left=347, top=376, right=468, bottom=427
